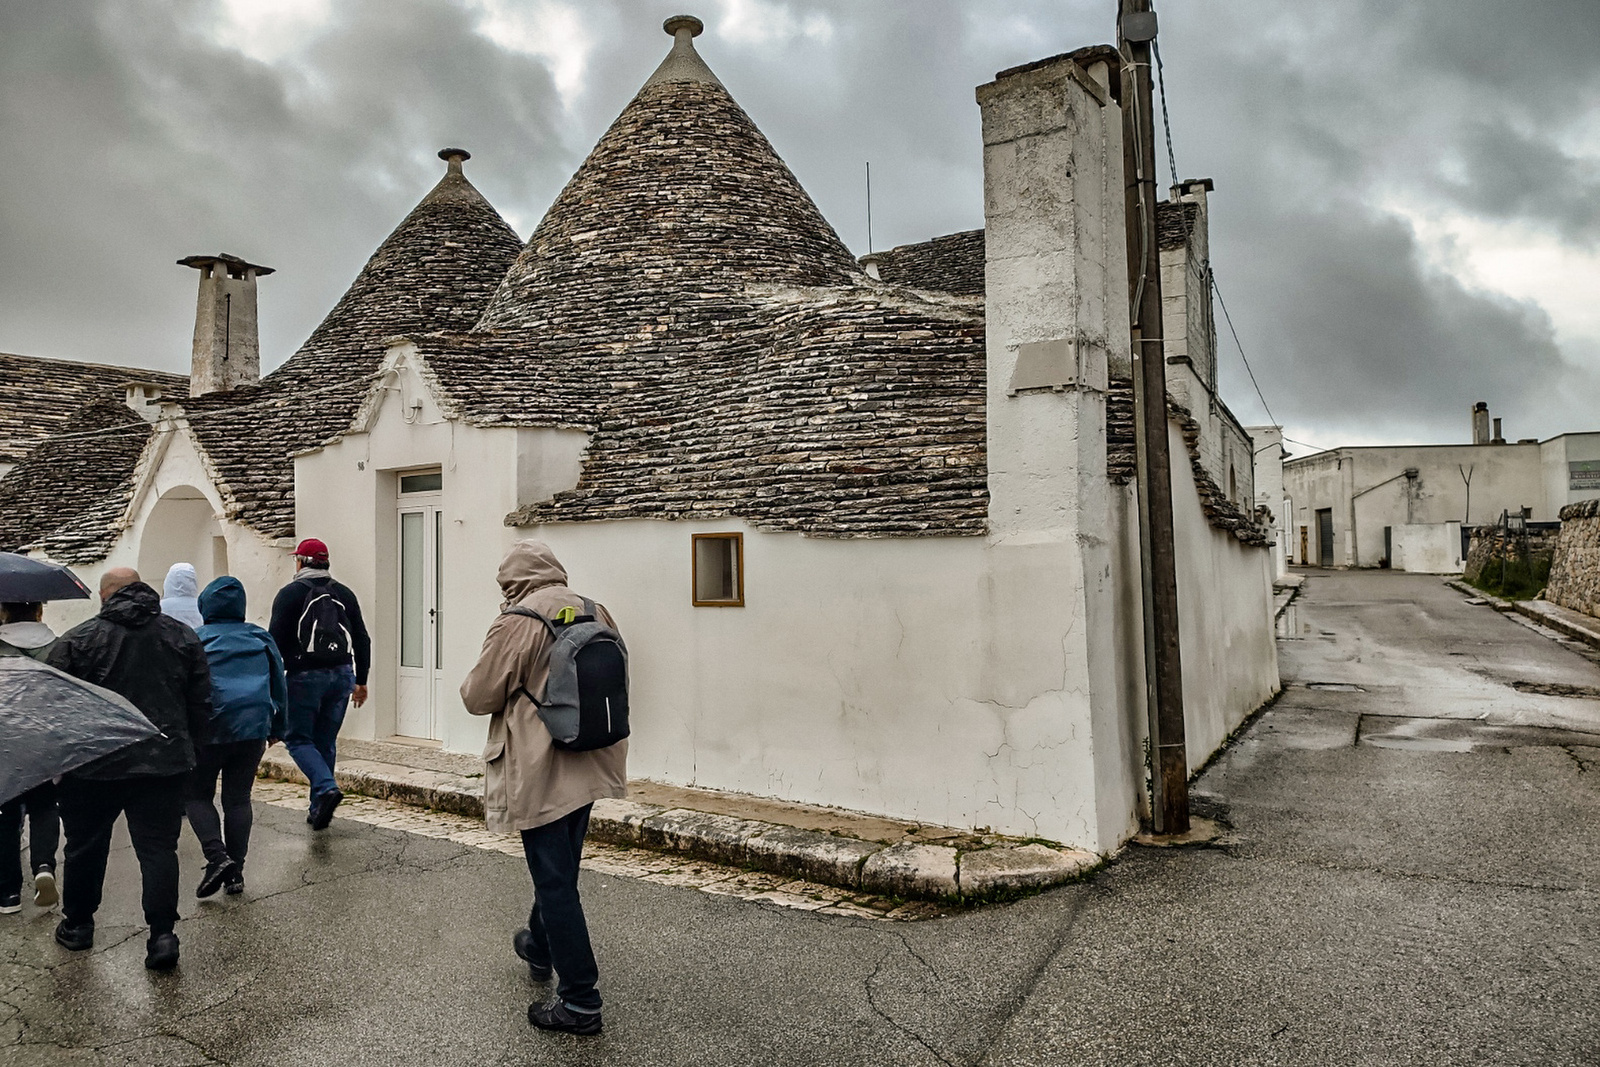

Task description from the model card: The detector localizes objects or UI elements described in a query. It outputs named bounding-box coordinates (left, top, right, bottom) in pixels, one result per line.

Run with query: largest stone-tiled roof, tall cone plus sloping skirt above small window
left=419, top=27, right=989, bottom=536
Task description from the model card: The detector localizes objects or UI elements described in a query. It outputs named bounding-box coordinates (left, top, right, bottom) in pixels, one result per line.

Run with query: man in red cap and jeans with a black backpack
left=267, top=537, right=373, bottom=830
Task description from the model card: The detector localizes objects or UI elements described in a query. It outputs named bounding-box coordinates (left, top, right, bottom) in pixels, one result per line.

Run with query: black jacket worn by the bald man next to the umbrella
left=45, top=582, right=211, bottom=779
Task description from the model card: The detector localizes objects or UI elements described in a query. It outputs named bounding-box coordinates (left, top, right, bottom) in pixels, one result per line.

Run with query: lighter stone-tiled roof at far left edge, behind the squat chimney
left=0, top=352, right=189, bottom=462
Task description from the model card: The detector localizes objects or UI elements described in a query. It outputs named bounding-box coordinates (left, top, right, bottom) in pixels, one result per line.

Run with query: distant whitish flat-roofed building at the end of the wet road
left=1283, top=402, right=1600, bottom=571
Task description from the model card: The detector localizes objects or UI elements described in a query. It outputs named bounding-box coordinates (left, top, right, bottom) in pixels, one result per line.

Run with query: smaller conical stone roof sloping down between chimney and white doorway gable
left=184, top=159, right=522, bottom=537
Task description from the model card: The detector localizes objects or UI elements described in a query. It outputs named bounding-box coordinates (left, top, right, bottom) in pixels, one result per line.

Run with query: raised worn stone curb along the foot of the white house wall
left=261, top=749, right=1101, bottom=902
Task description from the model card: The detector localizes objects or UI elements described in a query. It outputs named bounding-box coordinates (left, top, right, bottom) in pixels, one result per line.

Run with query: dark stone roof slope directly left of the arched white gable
left=0, top=400, right=152, bottom=563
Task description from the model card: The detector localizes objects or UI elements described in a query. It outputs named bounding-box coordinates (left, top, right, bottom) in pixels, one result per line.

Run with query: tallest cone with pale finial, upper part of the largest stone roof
left=478, top=16, right=861, bottom=330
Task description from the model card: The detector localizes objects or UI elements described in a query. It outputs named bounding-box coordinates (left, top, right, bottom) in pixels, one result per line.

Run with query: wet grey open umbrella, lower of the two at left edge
left=0, top=656, right=162, bottom=803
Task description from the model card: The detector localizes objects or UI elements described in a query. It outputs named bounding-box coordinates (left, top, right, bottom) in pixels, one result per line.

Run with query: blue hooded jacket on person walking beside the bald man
left=195, top=574, right=288, bottom=744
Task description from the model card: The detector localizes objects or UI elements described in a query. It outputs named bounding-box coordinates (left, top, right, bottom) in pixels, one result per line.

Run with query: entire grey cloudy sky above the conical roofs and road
left=0, top=0, right=1600, bottom=445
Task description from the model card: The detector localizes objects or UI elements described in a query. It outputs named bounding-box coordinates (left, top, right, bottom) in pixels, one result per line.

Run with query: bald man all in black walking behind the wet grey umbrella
left=45, top=566, right=211, bottom=971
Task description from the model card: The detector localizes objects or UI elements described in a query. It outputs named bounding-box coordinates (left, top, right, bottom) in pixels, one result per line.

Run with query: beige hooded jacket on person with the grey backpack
left=461, top=541, right=627, bottom=832
